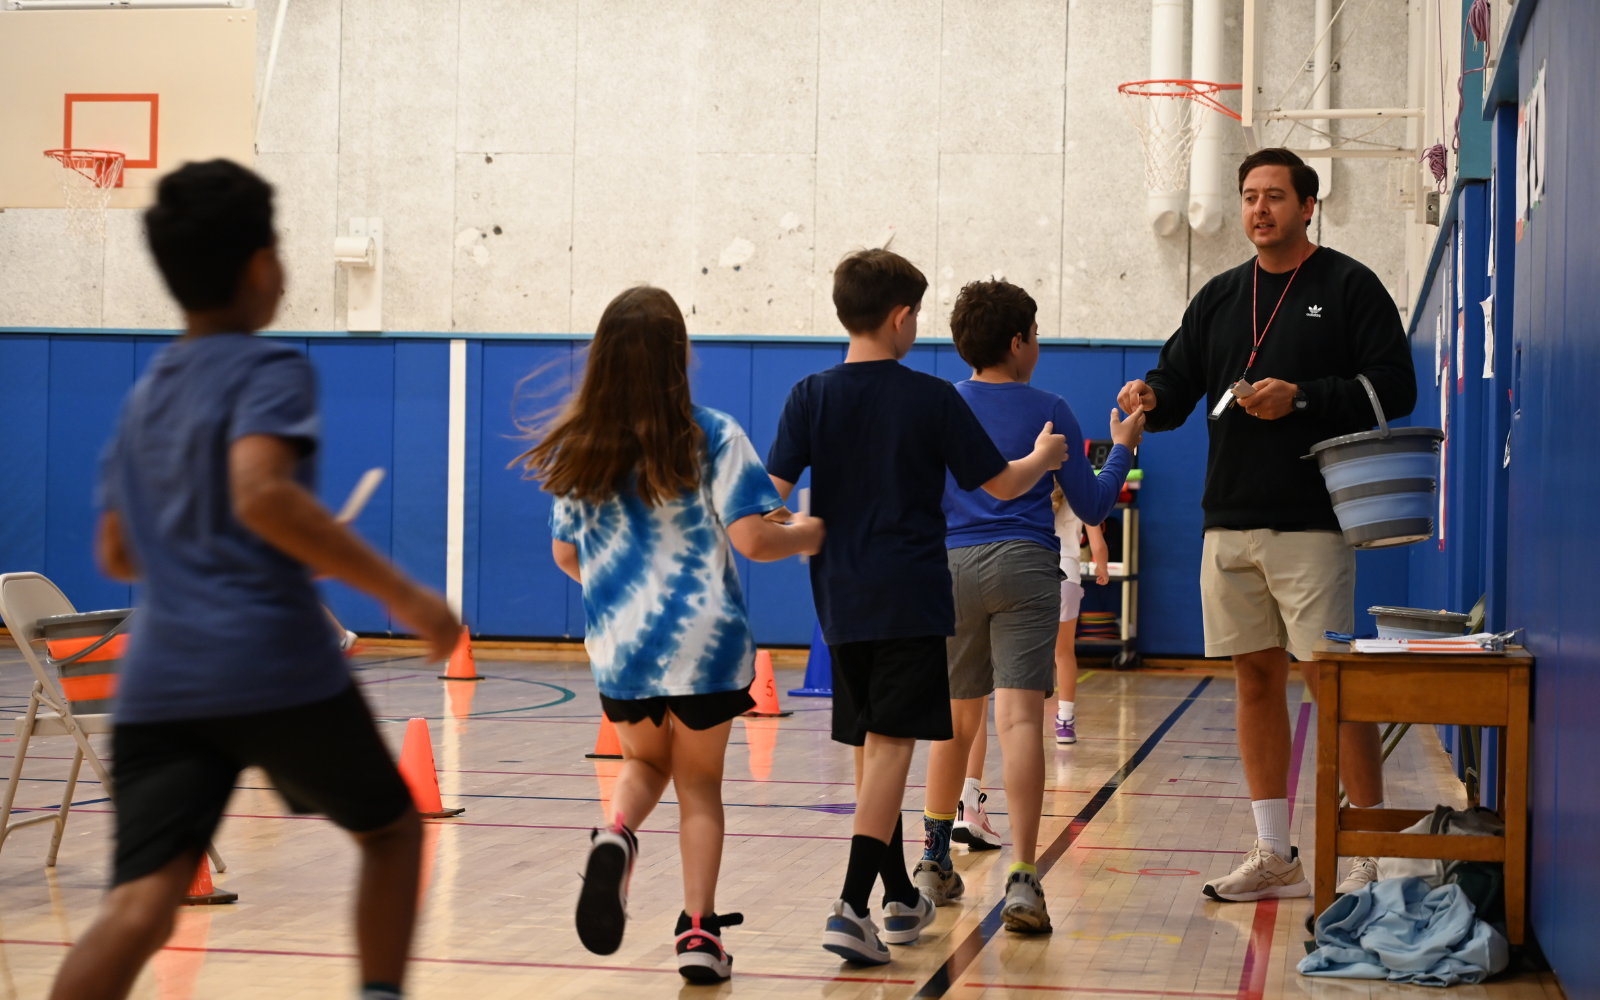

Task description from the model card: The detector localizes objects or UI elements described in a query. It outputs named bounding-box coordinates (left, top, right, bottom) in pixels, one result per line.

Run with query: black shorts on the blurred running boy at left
left=110, top=685, right=411, bottom=885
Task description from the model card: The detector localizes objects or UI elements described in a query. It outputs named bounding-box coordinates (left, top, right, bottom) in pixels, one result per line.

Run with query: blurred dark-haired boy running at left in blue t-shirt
left=51, top=160, right=461, bottom=1000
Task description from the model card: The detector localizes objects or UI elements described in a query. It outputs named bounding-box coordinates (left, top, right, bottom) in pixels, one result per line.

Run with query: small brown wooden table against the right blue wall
left=1312, top=642, right=1533, bottom=944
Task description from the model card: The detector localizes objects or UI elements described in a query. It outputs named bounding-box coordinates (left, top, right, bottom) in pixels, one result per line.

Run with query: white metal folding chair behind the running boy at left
left=0, top=573, right=227, bottom=872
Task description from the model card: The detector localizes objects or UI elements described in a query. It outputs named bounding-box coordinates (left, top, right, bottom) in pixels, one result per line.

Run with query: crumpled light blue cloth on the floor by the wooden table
left=1299, top=878, right=1510, bottom=986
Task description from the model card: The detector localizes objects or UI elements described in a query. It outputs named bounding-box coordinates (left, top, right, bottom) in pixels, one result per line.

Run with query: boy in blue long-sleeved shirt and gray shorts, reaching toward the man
left=914, top=282, right=1144, bottom=933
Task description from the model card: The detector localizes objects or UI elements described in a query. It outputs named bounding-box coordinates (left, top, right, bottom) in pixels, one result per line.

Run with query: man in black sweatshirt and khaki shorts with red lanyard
left=1118, top=149, right=1416, bottom=902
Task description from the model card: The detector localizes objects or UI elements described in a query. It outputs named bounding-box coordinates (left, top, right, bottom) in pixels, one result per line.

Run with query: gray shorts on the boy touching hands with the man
left=946, top=539, right=1062, bottom=699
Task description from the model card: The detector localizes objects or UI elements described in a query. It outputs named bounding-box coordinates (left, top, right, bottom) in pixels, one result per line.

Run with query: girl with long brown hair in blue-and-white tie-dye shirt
left=523, top=286, right=822, bottom=982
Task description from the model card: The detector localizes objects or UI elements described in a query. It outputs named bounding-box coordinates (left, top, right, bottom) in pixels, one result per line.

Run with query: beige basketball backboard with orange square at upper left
left=0, top=8, right=256, bottom=208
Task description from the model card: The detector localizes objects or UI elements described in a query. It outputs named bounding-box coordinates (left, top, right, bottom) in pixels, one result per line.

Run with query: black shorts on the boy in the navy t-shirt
left=827, top=635, right=955, bottom=747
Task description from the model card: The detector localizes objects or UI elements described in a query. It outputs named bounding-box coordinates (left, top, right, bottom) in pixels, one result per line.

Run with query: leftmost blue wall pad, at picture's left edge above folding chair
left=0, top=336, right=50, bottom=582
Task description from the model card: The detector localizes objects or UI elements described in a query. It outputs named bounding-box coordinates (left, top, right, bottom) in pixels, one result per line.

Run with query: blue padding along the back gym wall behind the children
left=0, top=334, right=1427, bottom=654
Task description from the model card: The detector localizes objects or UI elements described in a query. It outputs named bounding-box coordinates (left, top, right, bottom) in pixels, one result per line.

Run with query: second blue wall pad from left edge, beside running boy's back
left=43, top=336, right=134, bottom=611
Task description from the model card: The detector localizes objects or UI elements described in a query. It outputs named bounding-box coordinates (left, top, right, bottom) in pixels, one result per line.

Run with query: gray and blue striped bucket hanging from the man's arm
left=1306, top=374, right=1445, bottom=549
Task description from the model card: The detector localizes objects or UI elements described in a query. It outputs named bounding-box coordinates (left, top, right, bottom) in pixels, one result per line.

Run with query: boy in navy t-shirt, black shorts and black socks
left=766, top=250, right=1067, bottom=965
